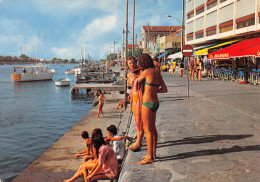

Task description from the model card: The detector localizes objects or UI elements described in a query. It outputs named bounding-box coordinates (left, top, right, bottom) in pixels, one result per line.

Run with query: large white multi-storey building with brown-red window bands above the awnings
left=185, top=0, right=260, bottom=46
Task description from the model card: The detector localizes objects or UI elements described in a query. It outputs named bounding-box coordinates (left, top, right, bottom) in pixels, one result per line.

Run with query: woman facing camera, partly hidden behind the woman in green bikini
left=127, top=56, right=144, bottom=151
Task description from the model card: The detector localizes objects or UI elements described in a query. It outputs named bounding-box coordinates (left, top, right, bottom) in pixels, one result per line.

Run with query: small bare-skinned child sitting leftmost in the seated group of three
left=75, top=131, right=94, bottom=163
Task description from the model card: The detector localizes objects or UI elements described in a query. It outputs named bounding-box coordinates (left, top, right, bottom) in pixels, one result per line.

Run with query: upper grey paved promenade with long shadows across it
left=120, top=73, right=260, bottom=182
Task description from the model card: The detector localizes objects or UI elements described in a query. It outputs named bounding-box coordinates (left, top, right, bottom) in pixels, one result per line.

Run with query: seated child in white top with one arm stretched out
left=105, top=125, right=131, bottom=160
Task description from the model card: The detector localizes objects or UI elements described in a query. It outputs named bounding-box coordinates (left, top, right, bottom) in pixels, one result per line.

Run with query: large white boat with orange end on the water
left=12, top=64, right=55, bottom=82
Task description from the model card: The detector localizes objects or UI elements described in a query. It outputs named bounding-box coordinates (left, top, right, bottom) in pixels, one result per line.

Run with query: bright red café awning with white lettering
left=208, top=37, right=260, bottom=59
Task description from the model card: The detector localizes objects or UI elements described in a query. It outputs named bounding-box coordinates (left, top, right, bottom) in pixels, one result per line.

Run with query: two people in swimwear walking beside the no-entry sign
left=189, top=58, right=204, bottom=81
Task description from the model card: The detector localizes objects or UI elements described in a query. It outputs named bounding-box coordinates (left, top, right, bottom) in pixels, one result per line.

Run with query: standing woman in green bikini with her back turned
left=138, top=54, right=168, bottom=165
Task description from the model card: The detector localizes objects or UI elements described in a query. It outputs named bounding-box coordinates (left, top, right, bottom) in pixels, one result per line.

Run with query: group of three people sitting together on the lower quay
left=64, top=125, right=131, bottom=182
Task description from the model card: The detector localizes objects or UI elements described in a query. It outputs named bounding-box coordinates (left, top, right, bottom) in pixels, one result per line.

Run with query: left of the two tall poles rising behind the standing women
left=124, top=0, right=128, bottom=110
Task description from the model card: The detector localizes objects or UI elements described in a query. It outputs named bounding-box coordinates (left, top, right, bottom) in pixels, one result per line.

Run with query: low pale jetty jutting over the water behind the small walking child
left=70, top=84, right=124, bottom=93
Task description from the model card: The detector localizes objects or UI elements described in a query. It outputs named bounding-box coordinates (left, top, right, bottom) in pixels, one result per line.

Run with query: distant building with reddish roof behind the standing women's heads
left=142, top=26, right=181, bottom=52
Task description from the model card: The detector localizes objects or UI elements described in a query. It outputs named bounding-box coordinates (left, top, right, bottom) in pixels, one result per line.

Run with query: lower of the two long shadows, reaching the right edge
left=158, top=145, right=260, bottom=161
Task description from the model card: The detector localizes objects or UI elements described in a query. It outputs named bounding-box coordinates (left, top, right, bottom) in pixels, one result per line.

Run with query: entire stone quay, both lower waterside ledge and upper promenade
left=14, top=73, right=260, bottom=182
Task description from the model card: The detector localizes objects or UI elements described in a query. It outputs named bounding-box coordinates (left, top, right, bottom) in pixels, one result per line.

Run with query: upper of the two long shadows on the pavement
left=157, top=135, right=254, bottom=148
